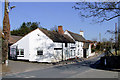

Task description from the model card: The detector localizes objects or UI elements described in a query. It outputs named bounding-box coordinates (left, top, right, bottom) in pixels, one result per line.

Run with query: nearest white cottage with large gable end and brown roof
left=10, top=28, right=75, bottom=63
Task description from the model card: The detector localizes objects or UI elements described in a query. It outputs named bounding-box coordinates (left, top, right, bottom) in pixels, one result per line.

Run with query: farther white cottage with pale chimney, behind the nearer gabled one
left=64, top=30, right=91, bottom=58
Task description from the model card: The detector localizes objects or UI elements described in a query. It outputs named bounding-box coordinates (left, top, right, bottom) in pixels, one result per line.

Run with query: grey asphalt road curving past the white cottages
left=4, top=54, right=118, bottom=78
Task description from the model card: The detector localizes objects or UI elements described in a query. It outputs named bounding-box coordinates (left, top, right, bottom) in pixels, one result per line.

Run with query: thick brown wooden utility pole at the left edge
left=2, top=0, right=10, bottom=65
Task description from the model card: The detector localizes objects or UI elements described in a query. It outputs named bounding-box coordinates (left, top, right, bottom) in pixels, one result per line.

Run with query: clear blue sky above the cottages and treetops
left=0, top=2, right=118, bottom=41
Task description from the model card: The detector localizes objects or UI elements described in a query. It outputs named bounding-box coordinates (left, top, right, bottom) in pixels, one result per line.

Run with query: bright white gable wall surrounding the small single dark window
left=29, top=29, right=55, bottom=62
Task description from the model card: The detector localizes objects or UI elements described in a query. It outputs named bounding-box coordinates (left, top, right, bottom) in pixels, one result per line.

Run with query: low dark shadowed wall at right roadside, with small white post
left=100, top=56, right=120, bottom=69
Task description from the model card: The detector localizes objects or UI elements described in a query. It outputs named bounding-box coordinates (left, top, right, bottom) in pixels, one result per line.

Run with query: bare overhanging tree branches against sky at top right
left=73, top=2, right=120, bottom=22
